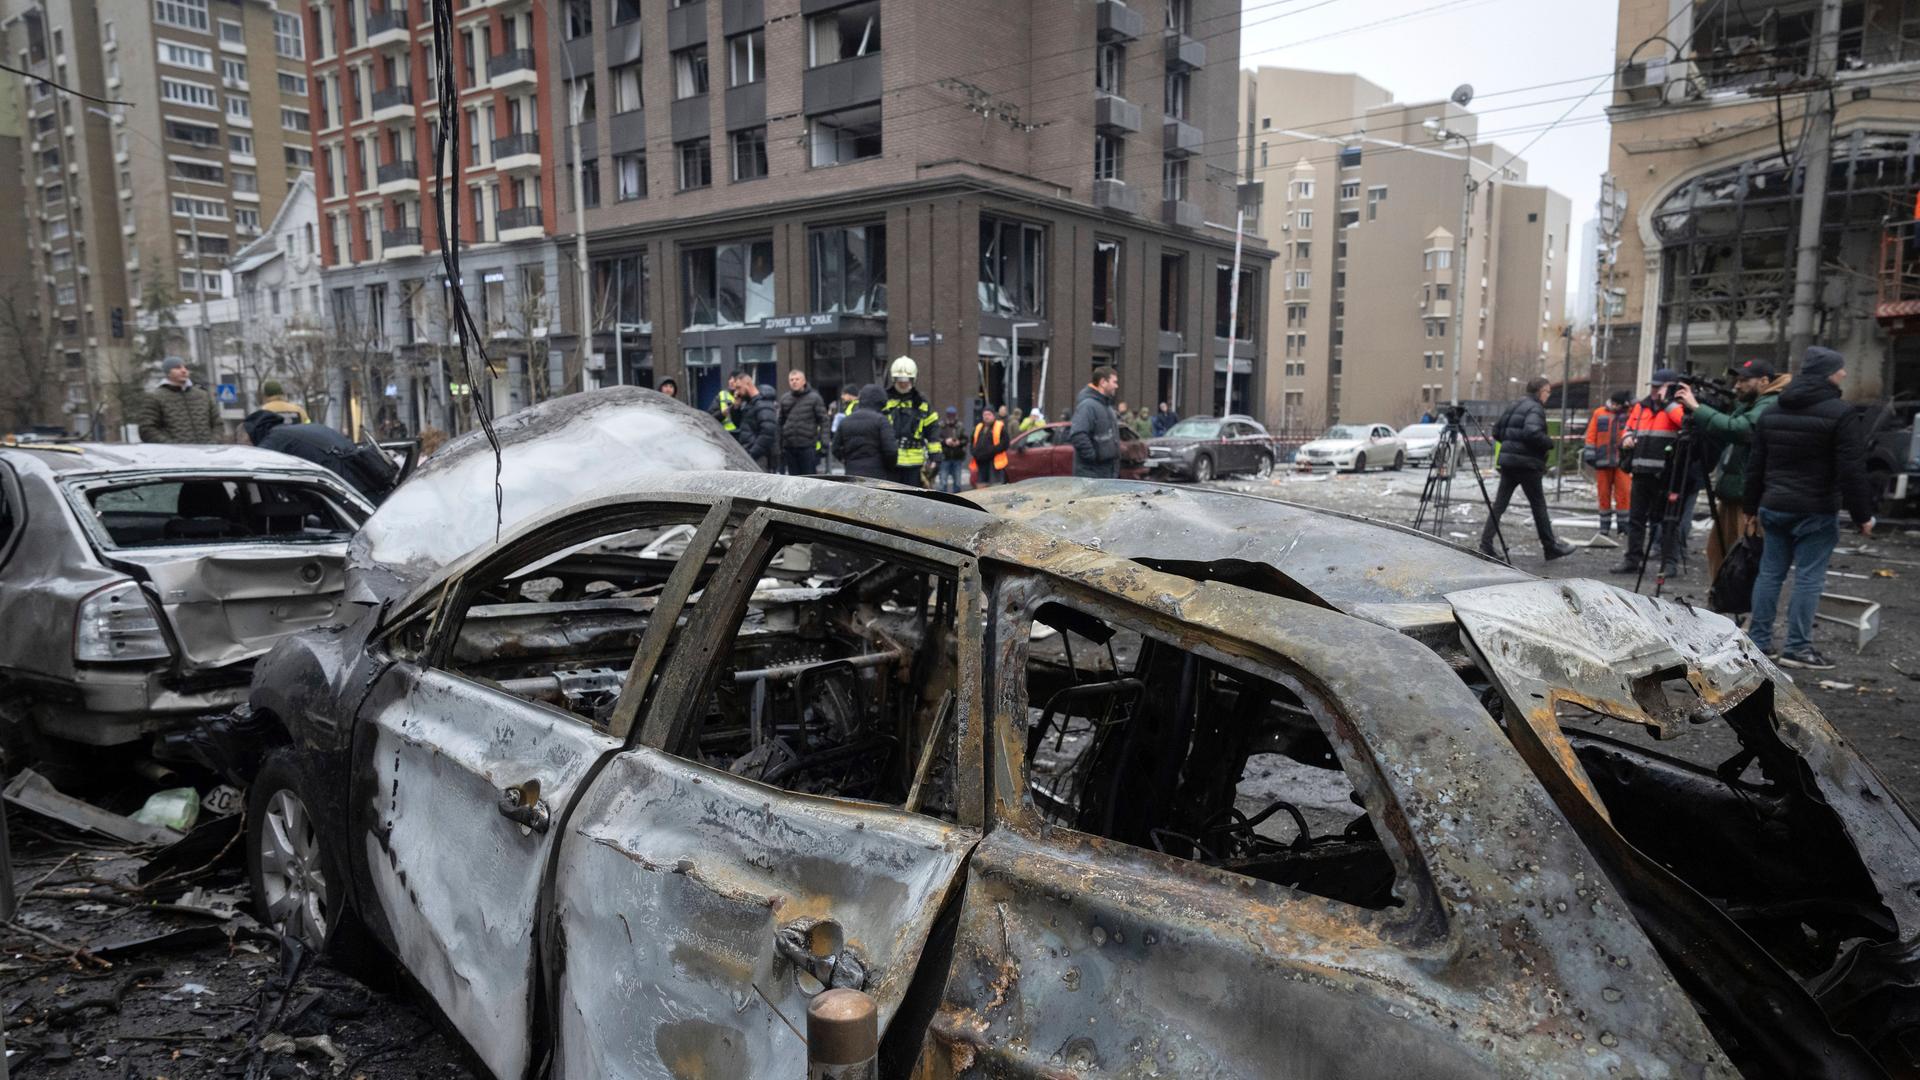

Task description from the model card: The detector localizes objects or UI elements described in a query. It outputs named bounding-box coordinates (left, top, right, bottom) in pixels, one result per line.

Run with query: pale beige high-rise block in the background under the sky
left=1244, top=67, right=1572, bottom=429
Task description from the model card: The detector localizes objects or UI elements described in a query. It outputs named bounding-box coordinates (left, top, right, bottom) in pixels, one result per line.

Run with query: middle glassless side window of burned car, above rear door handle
left=687, top=540, right=962, bottom=821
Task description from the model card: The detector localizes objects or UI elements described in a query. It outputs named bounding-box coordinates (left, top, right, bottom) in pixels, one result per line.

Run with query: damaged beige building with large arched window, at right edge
left=1594, top=0, right=1920, bottom=400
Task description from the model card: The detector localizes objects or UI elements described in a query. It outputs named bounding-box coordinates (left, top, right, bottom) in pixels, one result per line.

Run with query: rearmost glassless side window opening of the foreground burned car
left=1027, top=603, right=1400, bottom=909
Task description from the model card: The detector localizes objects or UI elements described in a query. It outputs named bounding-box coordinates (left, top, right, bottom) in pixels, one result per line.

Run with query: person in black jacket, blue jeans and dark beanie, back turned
left=1745, top=346, right=1874, bottom=671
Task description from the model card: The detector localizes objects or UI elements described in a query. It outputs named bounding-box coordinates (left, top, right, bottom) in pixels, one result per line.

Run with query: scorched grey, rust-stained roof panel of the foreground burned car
left=962, top=477, right=1536, bottom=628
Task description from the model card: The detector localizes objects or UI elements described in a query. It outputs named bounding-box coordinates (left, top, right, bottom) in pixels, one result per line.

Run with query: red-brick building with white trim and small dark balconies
left=307, top=0, right=570, bottom=430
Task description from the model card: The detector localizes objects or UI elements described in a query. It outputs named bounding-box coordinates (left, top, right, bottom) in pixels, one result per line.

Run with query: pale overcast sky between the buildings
left=1240, top=0, right=1619, bottom=244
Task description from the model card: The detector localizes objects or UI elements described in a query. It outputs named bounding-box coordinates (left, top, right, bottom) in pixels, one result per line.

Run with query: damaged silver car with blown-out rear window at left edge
left=0, top=442, right=372, bottom=753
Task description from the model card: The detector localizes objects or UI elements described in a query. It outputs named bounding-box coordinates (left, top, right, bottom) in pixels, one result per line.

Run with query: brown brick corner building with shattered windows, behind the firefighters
left=547, top=0, right=1269, bottom=415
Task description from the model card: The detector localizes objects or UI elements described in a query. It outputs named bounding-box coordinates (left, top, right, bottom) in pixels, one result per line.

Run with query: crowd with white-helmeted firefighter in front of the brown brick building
left=698, top=356, right=1179, bottom=492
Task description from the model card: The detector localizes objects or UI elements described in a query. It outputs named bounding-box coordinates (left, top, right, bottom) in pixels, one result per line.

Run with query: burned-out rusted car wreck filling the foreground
left=210, top=392, right=1920, bottom=1078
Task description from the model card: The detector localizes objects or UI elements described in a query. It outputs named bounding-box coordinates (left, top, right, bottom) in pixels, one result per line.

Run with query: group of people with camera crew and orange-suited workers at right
left=1480, top=346, right=1878, bottom=671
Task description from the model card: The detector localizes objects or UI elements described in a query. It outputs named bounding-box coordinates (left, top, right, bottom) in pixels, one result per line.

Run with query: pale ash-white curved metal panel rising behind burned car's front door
left=348, top=386, right=760, bottom=603
